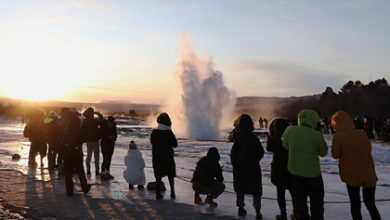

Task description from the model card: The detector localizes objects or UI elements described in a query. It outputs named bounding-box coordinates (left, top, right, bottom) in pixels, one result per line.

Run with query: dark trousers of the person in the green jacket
left=291, top=174, right=325, bottom=220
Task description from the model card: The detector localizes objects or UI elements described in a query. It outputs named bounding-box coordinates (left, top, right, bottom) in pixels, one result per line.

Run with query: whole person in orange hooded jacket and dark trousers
left=332, top=111, right=381, bottom=220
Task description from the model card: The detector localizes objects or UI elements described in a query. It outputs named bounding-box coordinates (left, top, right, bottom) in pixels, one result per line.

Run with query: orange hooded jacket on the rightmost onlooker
left=332, top=111, right=378, bottom=187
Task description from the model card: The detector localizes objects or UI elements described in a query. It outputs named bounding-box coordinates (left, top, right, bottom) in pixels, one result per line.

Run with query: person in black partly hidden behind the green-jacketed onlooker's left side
left=267, top=118, right=294, bottom=220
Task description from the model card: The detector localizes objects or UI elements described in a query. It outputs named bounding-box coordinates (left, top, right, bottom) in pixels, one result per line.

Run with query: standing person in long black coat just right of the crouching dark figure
left=230, top=114, right=264, bottom=219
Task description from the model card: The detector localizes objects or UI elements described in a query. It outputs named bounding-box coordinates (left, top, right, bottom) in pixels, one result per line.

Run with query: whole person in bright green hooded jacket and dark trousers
left=282, top=109, right=328, bottom=220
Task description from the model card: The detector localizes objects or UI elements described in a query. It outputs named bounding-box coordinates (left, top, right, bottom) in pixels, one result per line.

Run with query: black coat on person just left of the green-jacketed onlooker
left=267, top=118, right=290, bottom=189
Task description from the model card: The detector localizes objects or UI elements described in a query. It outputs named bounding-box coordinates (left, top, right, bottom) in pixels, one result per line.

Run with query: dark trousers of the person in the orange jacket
left=347, top=185, right=381, bottom=220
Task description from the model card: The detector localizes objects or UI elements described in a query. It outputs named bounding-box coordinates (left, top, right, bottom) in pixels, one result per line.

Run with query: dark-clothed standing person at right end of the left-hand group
left=100, top=116, right=117, bottom=180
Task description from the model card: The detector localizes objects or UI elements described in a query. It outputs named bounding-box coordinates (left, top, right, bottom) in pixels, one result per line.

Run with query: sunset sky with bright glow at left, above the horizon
left=0, top=0, right=390, bottom=103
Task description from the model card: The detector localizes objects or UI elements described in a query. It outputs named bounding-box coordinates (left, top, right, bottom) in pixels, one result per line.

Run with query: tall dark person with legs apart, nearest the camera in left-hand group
left=62, top=108, right=91, bottom=196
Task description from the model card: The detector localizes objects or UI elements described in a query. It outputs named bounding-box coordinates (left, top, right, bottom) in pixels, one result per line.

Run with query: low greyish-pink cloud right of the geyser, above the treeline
left=227, top=61, right=348, bottom=96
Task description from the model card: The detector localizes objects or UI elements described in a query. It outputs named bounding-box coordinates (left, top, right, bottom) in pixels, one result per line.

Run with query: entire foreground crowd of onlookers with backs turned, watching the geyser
left=24, top=108, right=381, bottom=220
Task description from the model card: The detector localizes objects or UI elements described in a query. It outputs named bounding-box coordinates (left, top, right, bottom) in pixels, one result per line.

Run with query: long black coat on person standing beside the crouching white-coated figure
left=150, top=129, right=177, bottom=178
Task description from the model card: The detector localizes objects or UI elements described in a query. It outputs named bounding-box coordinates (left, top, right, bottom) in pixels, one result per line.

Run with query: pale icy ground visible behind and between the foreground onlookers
left=0, top=119, right=390, bottom=219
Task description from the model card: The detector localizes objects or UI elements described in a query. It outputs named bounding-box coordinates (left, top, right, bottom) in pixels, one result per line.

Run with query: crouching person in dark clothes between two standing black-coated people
left=191, top=147, right=225, bottom=206
